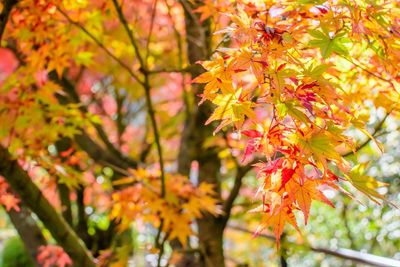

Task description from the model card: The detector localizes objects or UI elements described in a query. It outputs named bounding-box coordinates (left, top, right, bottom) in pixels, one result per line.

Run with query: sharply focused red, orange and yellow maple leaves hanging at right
left=194, top=1, right=400, bottom=243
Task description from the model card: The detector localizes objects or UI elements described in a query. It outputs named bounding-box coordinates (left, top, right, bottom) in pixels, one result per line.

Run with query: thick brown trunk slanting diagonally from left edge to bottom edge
left=0, top=146, right=95, bottom=267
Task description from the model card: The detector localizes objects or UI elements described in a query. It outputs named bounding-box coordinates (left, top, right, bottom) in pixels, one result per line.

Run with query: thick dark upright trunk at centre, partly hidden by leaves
left=178, top=0, right=225, bottom=267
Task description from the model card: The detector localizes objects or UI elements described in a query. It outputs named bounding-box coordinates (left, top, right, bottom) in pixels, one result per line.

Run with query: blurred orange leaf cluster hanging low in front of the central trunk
left=111, top=169, right=219, bottom=245
